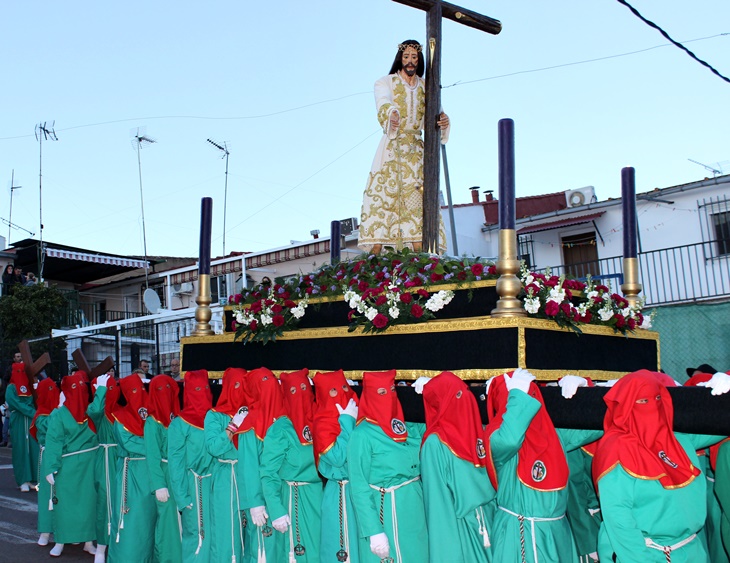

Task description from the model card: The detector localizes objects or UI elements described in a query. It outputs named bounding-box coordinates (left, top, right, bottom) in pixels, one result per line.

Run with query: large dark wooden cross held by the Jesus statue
left=394, top=0, right=502, bottom=253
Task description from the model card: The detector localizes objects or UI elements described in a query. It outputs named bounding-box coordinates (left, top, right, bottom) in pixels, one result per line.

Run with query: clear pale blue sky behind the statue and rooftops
left=0, top=0, right=730, bottom=256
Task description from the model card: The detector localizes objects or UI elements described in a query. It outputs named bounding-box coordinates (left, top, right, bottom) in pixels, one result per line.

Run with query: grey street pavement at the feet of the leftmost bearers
left=0, top=448, right=89, bottom=563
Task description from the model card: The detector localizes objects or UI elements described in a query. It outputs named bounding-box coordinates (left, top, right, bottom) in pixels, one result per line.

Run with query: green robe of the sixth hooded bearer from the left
left=144, top=417, right=182, bottom=563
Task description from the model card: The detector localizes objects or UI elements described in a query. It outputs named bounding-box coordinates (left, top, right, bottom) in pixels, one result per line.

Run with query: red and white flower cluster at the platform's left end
left=232, top=284, right=309, bottom=344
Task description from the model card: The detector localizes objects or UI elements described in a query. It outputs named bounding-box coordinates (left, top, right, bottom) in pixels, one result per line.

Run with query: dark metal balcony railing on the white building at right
left=536, top=241, right=730, bottom=306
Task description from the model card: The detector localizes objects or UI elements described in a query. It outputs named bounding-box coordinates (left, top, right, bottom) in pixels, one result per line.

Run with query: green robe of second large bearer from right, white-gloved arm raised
left=490, top=390, right=602, bottom=563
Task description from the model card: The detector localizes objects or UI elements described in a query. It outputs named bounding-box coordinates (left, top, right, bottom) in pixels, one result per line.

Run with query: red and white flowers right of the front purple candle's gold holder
left=520, top=264, right=651, bottom=334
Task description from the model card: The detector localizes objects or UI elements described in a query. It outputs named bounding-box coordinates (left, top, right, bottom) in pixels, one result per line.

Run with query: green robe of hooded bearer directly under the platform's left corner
left=167, top=417, right=213, bottom=563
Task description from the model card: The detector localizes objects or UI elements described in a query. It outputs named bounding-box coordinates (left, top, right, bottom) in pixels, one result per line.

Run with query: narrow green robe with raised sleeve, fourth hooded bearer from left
left=86, top=387, right=117, bottom=545
